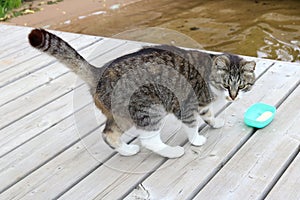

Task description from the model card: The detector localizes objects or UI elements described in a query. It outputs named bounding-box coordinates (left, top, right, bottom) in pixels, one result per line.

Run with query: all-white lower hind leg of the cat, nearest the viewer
left=139, top=129, right=184, bottom=158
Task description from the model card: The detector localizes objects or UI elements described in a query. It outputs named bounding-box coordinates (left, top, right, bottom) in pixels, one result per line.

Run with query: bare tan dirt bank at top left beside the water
left=2, top=0, right=141, bottom=29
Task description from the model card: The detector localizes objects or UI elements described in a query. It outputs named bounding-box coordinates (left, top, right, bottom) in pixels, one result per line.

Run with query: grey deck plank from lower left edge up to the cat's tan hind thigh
left=0, top=102, right=104, bottom=193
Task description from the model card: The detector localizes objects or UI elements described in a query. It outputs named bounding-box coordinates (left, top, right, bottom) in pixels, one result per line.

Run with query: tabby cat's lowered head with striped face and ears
left=210, top=54, right=256, bottom=100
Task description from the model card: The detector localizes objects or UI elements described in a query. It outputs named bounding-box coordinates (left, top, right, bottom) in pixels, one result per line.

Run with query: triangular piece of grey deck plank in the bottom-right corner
left=266, top=155, right=300, bottom=200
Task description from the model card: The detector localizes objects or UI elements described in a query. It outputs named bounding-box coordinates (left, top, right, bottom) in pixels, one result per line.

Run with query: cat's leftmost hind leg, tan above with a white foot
left=102, top=119, right=140, bottom=156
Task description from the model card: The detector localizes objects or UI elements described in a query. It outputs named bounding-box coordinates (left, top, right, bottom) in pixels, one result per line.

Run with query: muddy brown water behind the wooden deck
left=54, top=0, right=300, bottom=62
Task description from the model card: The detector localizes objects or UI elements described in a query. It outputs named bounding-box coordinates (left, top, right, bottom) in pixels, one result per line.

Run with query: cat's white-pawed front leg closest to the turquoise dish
left=199, top=105, right=225, bottom=128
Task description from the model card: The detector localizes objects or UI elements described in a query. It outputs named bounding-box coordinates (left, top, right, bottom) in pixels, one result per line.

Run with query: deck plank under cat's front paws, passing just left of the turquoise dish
left=118, top=62, right=300, bottom=199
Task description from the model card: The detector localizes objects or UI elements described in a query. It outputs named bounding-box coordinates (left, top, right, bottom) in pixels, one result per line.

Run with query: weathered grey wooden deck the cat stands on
left=0, top=25, right=300, bottom=200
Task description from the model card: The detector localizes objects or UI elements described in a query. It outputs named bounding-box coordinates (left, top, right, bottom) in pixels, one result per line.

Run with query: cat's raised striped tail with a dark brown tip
left=28, top=29, right=100, bottom=90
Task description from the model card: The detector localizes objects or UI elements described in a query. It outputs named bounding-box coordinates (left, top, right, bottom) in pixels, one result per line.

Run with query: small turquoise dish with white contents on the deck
left=244, top=103, right=276, bottom=128
